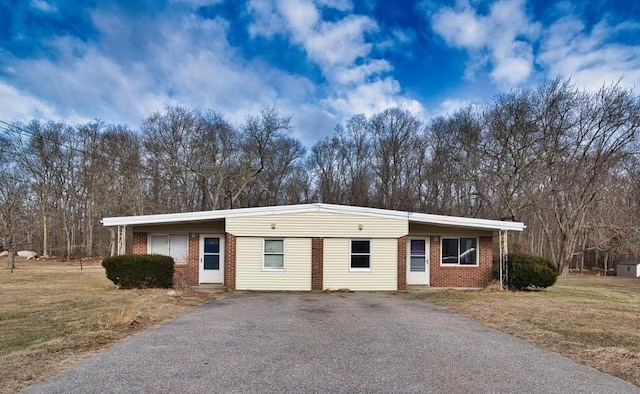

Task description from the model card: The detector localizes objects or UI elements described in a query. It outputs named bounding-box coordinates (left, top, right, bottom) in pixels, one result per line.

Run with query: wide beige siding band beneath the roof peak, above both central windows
left=226, top=212, right=408, bottom=238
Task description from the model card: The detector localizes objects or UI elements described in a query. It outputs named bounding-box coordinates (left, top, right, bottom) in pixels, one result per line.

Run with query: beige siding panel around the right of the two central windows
left=323, top=238, right=398, bottom=290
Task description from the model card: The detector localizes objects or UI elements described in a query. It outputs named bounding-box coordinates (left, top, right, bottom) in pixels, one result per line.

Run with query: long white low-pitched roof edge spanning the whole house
left=102, top=203, right=526, bottom=231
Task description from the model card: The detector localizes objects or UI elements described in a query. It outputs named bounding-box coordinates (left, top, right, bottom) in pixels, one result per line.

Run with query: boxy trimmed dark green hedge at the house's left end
left=102, top=254, right=174, bottom=289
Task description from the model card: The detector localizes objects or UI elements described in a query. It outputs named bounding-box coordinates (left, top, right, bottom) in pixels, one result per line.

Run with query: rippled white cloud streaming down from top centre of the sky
left=249, top=0, right=423, bottom=120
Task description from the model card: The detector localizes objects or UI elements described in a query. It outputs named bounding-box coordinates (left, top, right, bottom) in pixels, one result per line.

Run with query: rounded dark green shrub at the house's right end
left=507, top=254, right=558, bottom=290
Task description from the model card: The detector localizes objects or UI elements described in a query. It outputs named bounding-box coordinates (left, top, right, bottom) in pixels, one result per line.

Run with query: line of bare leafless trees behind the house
left=0, top=78, right=640, bottom=273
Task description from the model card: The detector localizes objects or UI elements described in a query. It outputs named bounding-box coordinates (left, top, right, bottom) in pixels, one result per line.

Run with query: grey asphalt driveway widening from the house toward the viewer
left=26, top=293, right=640, bottom=393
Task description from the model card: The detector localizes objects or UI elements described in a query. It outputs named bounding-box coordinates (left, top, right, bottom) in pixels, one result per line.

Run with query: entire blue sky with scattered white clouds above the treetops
left=0, top=0, right=640, bottom=145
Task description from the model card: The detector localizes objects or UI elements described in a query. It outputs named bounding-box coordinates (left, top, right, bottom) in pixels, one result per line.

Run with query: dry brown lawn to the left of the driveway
left=0, top=258, right=211, bottom=393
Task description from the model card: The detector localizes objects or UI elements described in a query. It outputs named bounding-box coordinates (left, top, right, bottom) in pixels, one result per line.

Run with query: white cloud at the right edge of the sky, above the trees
left=538, top=16, right=640, bottom=89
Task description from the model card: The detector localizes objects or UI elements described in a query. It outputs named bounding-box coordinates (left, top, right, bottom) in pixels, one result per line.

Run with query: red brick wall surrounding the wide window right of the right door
left=430, top=237, right=493, bottom=287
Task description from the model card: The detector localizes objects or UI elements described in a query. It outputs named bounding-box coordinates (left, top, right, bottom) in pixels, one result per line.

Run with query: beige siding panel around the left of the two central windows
left=236, top=237, right=311, bottom=290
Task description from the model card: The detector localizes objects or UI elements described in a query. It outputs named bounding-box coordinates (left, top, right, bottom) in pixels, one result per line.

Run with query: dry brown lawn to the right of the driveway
left=414, top=276, right=640, bottom=386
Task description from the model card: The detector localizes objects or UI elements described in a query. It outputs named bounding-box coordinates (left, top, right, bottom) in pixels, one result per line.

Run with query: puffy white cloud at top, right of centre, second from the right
left=431, top=0, right=540, bottom=86
